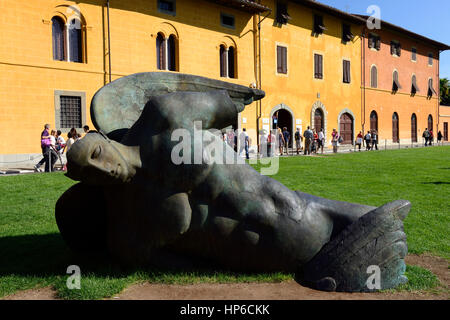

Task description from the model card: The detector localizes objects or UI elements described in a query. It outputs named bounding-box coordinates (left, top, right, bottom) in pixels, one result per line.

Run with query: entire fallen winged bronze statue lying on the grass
left=55, top=72, right=410, bottom=292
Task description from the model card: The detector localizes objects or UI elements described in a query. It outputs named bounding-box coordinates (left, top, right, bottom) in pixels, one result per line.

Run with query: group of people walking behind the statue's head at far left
left=34, top=123, right=90, bottom=172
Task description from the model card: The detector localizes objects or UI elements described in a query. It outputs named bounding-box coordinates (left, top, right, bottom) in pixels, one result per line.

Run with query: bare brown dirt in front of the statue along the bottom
left=4, top=254, right=450, bottom=300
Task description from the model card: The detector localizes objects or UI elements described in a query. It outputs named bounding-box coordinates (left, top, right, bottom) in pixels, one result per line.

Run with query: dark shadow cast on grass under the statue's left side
left=0, top=233, right=284, bottom=282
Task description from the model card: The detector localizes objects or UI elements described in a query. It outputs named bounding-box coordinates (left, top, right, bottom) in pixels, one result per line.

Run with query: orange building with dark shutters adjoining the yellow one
left=361, top=16, right=450, bottom=144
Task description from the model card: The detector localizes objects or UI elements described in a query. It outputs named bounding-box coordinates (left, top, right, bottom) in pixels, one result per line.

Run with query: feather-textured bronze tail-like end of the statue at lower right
left=296, top=200, right=411, bottom=292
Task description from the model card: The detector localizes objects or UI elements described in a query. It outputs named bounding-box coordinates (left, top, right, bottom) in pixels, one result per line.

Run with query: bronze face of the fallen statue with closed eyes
left=66, top=133, right=130, bottom=185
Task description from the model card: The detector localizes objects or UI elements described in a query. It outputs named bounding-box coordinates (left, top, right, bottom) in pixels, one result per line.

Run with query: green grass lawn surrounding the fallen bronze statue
left=0, top=147, right=450, bottom=299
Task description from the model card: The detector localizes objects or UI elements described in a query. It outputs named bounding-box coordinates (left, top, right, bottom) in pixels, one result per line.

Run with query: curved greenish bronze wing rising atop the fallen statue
left=91, top=72, right=265, bottom=140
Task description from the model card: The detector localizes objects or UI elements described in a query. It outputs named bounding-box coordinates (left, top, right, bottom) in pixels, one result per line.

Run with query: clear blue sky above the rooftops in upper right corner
left=318, top=0, right=450, bottom=79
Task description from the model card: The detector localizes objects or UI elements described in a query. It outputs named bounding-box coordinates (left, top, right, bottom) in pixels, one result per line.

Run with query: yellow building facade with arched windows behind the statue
left=0, top=0, right=448, bottom=167
